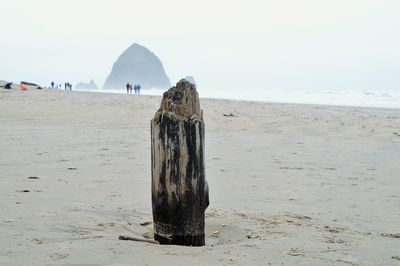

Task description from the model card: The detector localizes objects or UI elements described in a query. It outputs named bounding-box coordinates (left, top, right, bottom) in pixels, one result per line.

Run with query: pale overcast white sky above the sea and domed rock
left=0, top=0, right=400, bottom=91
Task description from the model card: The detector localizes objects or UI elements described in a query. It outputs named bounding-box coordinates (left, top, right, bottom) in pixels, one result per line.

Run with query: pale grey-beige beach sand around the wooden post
left=0, top=90, right=400, bottom=265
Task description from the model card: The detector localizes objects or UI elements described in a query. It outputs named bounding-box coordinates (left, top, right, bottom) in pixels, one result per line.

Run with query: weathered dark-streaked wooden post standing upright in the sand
left=151, top=79, right=209, bottom=246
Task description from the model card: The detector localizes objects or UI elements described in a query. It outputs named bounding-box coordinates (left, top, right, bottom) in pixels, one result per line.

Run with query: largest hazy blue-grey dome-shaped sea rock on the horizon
left=103, top=43, right=171, bottom=89
